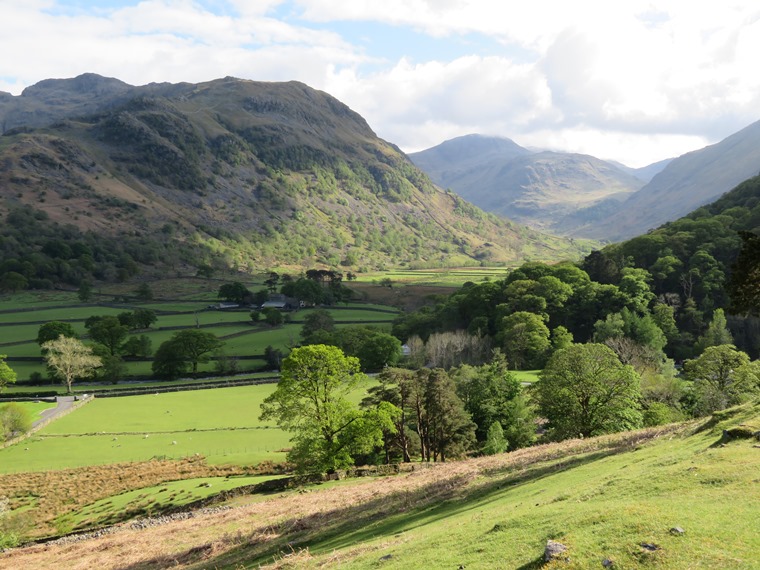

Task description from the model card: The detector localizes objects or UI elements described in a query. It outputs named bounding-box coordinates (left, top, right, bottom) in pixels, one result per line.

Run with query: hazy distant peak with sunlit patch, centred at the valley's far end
left=410, top=135, right=644, bottom=235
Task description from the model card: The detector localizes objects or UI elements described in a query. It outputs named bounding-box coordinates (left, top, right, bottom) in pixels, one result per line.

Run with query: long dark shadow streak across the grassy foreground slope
left=119, top=445, right=632, bottom=570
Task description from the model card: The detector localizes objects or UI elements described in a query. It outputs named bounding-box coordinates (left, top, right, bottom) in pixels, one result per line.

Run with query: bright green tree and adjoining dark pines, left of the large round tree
left=261, top=344, right=535, bottom=471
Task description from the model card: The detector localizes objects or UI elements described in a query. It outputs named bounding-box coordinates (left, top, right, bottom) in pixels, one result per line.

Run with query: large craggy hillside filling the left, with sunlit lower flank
left=0, top=74, right=578, bottom=288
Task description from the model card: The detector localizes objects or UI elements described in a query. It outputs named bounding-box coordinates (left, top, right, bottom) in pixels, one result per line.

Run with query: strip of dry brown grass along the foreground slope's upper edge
left=0, top=426, right=684, bottom=570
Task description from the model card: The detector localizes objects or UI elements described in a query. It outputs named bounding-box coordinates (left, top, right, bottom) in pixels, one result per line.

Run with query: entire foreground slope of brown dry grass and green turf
left=0, top=403, right=760, bottom=569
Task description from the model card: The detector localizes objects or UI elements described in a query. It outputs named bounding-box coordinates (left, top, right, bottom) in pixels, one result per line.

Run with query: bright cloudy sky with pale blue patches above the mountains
left=0, top=0, right=760, bottom=167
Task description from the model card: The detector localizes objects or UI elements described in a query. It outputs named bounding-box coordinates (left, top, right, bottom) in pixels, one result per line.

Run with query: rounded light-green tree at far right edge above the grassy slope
left=684, top=344, right=757, bottom=415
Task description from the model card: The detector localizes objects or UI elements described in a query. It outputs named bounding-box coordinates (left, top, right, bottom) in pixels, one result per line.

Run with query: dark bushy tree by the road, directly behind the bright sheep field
left=152, top=329, right=222, bottom=379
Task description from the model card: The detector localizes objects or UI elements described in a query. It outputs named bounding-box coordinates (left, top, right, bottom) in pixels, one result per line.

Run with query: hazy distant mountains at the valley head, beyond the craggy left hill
left=410, top=122, right=760, bottom=241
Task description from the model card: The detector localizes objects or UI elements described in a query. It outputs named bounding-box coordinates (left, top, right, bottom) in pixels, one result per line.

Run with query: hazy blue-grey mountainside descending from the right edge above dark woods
left=592, top=121, right=760, bottom=241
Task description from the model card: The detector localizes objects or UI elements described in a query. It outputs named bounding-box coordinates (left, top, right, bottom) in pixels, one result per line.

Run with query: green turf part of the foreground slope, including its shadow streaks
left=207, top=403, right=760, bottom=570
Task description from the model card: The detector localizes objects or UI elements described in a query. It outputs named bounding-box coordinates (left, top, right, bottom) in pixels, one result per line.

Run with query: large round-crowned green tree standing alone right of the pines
left=533, top=344, right=642, bottom=440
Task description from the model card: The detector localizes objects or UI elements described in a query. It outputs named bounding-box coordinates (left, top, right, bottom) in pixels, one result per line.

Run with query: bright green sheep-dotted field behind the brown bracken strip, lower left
left=0, top=380, right=378, bottom=473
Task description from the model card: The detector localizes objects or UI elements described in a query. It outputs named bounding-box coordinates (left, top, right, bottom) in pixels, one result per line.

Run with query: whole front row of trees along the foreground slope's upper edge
left=261, top=336, right=760, bottom=472
